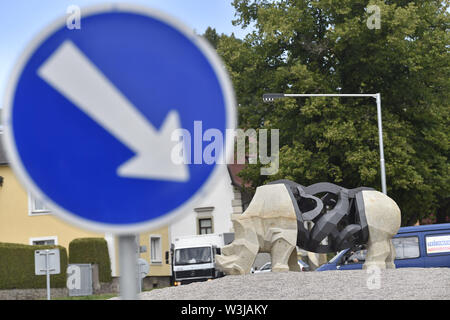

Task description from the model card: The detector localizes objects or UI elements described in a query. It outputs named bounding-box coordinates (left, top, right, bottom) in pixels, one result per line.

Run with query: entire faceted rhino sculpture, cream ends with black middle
left=216, top=180, right=401, bottom=274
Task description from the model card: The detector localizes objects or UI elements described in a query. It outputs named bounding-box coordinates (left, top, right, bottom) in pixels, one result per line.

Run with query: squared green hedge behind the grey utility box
left=69, top=238, right=112, bottom=282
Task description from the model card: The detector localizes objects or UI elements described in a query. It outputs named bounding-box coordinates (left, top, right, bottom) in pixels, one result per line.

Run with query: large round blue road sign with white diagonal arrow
left=4, top=5, right=236, bottom=233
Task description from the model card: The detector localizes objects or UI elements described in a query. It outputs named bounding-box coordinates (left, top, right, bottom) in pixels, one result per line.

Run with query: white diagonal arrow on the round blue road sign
left=38, top=40, right=189, bottom=182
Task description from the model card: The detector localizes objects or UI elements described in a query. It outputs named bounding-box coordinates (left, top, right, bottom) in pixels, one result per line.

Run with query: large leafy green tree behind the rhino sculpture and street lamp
left=208, top=0, right=450, bottom=225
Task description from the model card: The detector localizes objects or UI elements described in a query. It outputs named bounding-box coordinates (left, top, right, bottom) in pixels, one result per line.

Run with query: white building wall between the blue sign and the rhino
left=169, top=165, right=235, bottom=242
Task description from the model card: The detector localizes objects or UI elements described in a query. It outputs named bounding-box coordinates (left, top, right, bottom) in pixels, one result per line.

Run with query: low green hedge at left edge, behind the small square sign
left=0, top=242, right=67, bottom=289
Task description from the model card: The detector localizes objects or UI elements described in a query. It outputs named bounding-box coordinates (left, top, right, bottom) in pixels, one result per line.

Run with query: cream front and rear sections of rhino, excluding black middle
left=216, top=184, right=400, bottom=274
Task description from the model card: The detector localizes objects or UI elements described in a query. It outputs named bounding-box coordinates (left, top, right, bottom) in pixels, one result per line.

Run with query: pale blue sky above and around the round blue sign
left=0, top=0, right=250, bottom=107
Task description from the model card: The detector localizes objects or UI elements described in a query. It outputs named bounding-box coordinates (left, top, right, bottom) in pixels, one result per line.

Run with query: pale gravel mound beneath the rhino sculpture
left=140, top=268, right=450, bottom=300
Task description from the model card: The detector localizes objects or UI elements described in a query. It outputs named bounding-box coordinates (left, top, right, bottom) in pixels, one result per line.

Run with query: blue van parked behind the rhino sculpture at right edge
left=316, top=223, right=450, bottom=271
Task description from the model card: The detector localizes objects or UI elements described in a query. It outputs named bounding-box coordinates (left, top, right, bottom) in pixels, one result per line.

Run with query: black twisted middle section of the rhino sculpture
left=269, top=180, right=374, bottom=253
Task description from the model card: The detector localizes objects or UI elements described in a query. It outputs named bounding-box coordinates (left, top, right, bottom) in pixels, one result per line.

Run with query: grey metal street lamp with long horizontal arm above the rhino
left=263, top=93, right=387, bottom=194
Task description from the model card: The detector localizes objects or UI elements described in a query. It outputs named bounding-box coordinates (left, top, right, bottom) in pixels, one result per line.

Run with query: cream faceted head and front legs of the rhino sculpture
left=216, top=184, right=300, bottom=274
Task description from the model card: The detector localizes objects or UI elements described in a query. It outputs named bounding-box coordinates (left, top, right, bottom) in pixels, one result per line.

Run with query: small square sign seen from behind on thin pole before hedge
left=34, top=249, right=61, bottom=300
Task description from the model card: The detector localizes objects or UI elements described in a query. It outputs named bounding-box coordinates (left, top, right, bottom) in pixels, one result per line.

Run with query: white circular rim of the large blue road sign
left=3, top=4, right=237, bottom=234
